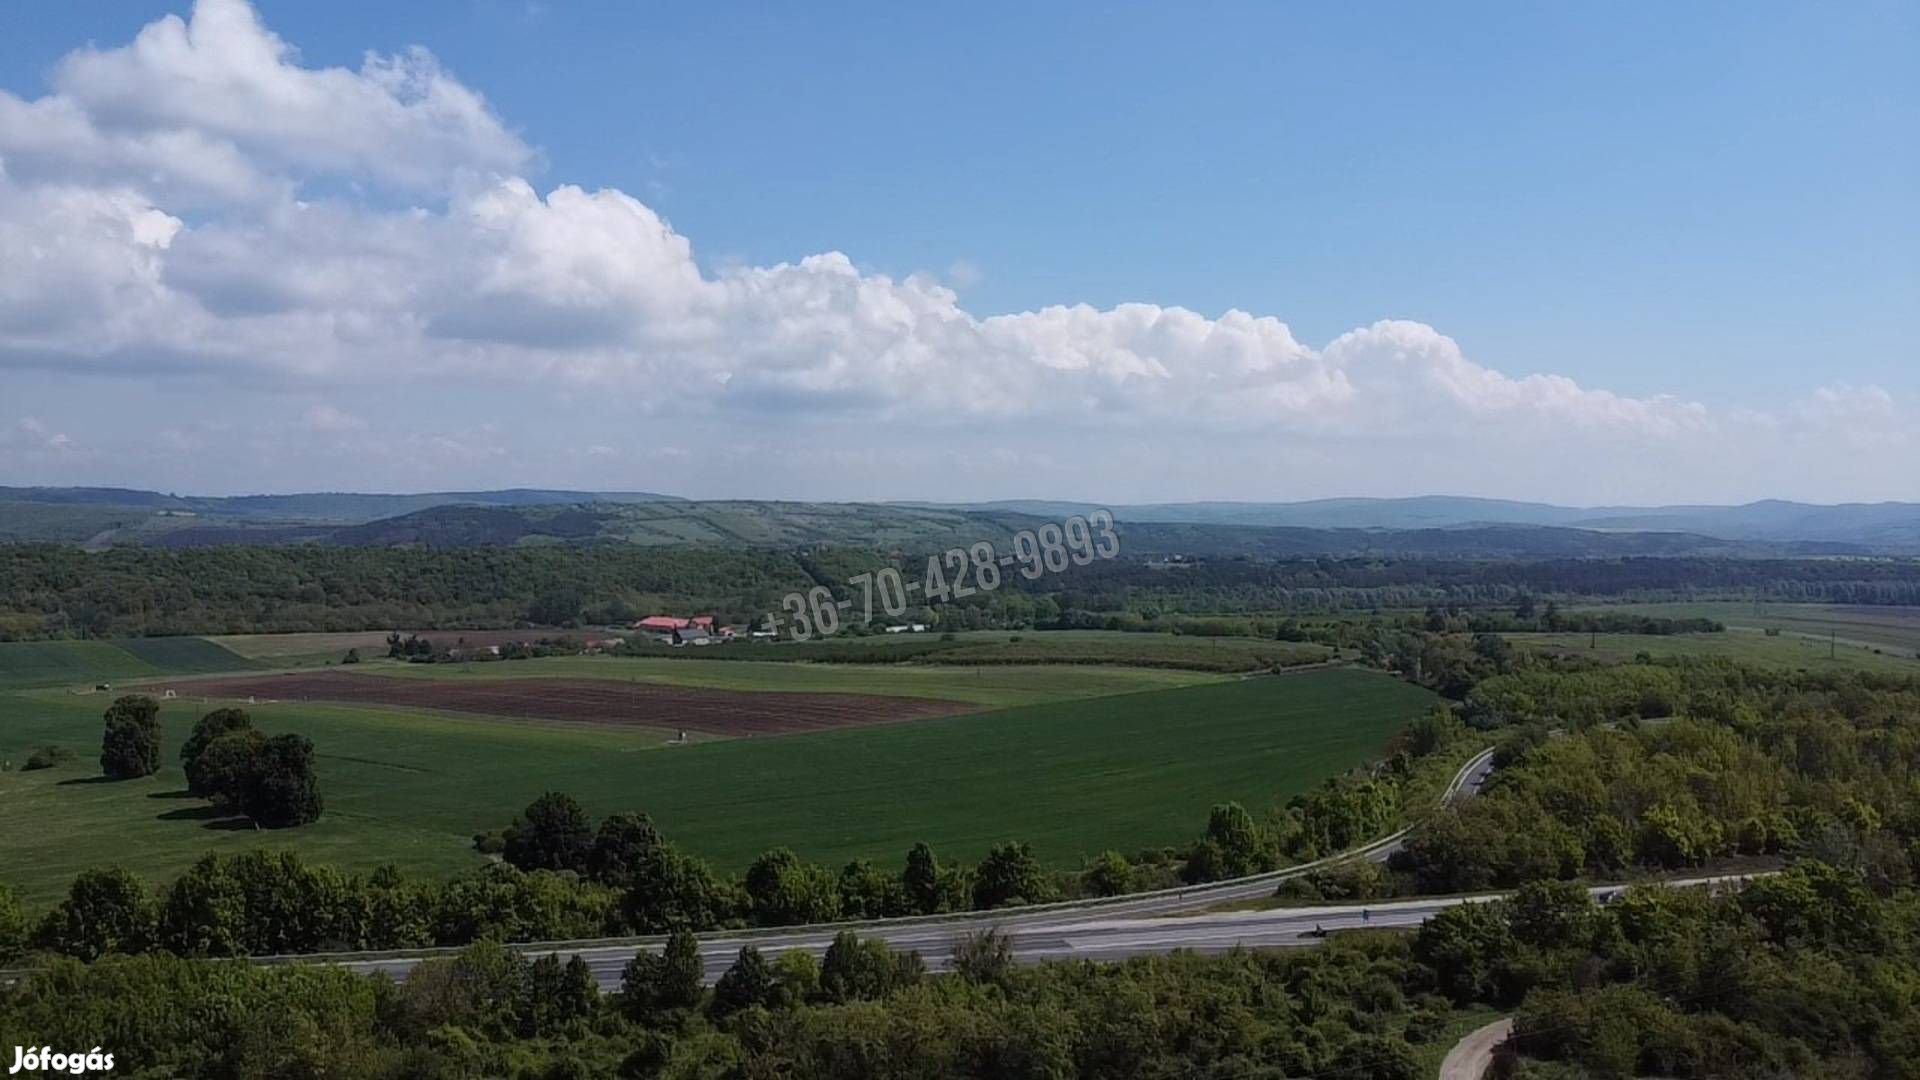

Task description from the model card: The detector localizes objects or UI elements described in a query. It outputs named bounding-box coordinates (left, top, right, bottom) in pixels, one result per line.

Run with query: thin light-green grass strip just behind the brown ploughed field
left=351, top=646, right=1223, bottom=709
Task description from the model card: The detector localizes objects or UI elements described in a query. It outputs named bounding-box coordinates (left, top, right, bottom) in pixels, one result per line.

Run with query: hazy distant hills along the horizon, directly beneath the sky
left=0, top=488, right=1920, bottom=557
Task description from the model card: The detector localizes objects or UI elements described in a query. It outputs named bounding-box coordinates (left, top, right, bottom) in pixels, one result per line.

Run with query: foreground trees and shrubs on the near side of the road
left=0, top=861, right=1920, bottom=1080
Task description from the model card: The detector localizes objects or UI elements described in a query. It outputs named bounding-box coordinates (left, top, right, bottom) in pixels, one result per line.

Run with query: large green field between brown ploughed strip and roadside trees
left=0, top=663, right=1434, bottom=907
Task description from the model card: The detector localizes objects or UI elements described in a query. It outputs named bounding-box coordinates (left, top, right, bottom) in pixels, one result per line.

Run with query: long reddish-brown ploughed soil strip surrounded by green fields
left=156, top=671, right=972, bottom=734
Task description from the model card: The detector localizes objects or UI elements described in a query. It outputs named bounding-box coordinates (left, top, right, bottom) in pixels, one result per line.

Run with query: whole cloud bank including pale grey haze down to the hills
left=0, top=0, right=1916, bottom=500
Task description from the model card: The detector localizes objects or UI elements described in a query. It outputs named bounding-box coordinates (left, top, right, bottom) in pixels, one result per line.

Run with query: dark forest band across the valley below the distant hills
left=0, top=544, right=1920, bottom=640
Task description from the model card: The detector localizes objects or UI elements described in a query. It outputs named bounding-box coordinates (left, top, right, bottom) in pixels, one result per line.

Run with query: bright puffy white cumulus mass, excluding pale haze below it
left=0, top=0, right=1914, bottom=498
